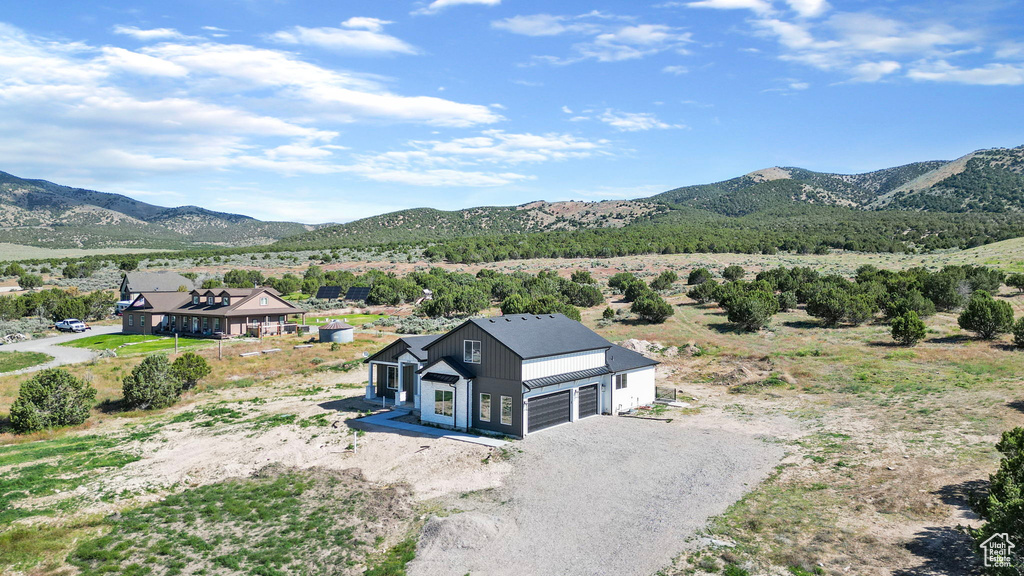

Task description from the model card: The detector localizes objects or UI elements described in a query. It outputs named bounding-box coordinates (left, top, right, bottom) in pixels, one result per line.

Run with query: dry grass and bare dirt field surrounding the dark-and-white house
left=0, top=241, right=1024, bottom=576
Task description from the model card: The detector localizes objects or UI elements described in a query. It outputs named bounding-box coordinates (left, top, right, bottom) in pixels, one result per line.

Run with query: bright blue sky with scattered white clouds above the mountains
left=0, top=0, right=1024, bottom=222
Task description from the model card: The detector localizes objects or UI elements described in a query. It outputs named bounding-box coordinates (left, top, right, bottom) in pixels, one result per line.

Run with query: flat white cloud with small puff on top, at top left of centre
left=269, top=17, right=418, bottom=54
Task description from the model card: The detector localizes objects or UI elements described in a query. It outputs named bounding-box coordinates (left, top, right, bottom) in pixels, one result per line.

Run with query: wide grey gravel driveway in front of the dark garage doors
left=409, top=415, right=783, bottom=576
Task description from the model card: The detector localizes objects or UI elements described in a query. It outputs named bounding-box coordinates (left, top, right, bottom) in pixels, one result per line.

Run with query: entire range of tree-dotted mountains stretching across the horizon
left=0, top=146, right=1024, bottom=249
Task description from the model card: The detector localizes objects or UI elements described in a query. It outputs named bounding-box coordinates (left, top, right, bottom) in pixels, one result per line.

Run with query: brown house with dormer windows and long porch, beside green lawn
left=121, top=287, right=305, bottom=336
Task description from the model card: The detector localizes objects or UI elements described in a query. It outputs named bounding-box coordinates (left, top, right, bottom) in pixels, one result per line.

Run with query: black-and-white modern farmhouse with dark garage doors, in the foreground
left=367, top=314, right=658, bottom=438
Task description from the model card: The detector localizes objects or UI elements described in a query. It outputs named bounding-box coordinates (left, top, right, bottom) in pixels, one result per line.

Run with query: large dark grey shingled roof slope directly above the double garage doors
left=460, top=314, right=611, bottom=360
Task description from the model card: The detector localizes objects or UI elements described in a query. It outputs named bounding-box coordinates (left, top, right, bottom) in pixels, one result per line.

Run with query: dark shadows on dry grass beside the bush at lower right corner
left=893, top=480, right=988, bottom=576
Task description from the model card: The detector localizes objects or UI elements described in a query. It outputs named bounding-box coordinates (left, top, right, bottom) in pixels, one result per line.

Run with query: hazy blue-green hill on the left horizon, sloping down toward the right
left=0, top=172, right=314, bottom=249
